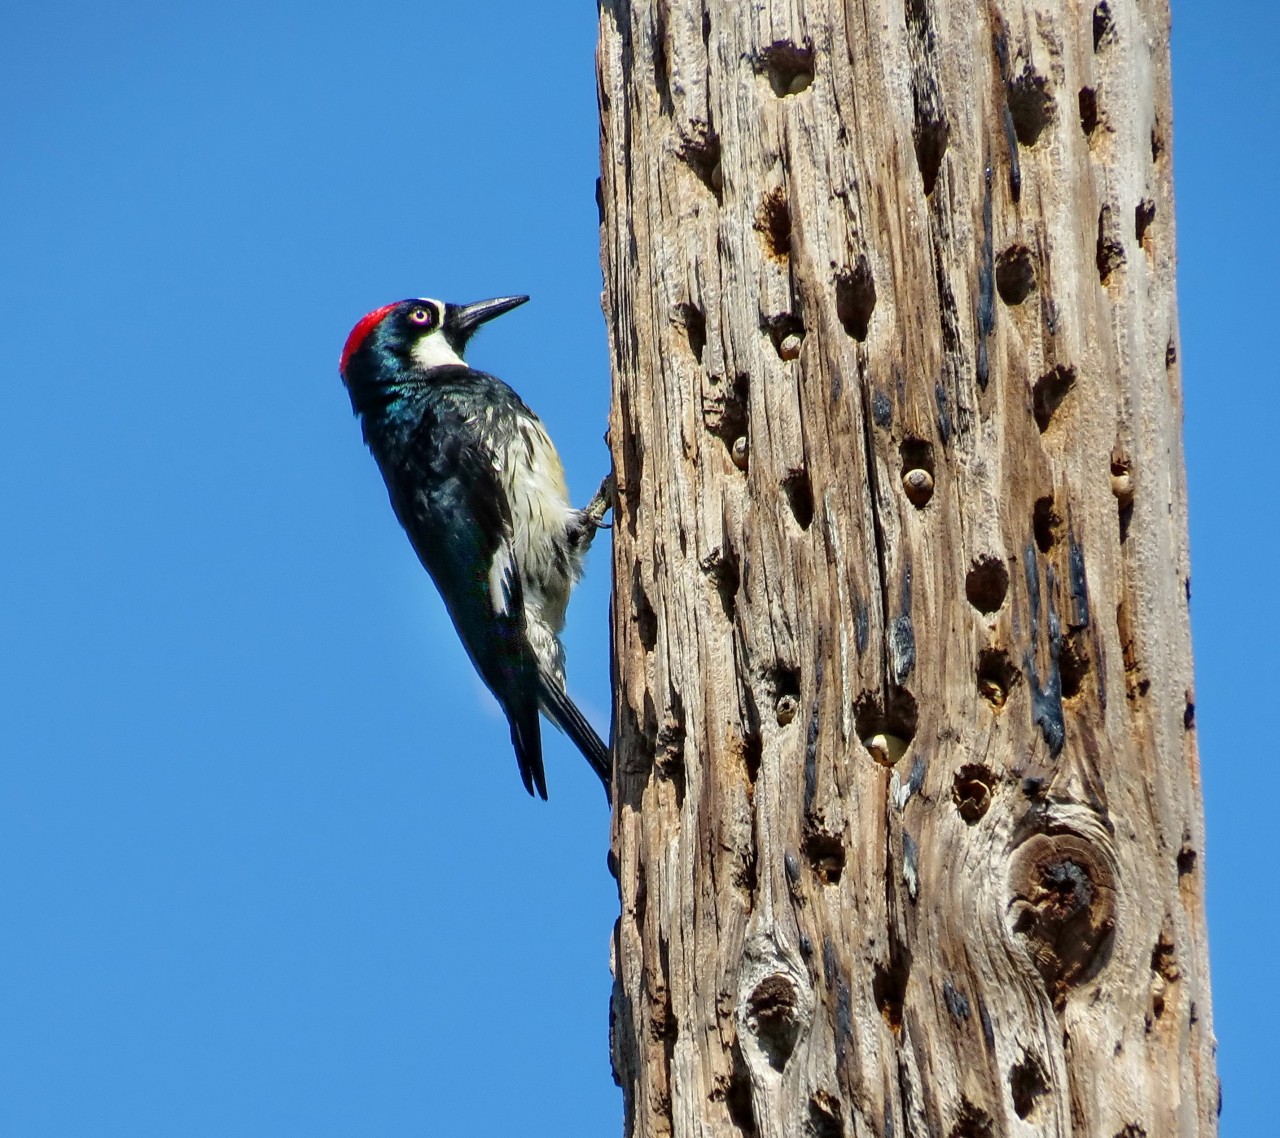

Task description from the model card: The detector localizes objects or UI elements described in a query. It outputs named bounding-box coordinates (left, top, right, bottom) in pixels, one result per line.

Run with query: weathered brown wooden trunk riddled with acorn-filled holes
left=599, top=0, right=1217, bottom=1138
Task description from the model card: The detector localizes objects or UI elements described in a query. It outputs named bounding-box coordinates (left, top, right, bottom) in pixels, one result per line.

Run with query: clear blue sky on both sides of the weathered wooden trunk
left=0, top=0, right=1280, bottom=1138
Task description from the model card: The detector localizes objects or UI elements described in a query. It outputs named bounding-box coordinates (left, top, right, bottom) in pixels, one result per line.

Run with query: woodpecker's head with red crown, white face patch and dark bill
left=338, top=297, right=529, bottom=412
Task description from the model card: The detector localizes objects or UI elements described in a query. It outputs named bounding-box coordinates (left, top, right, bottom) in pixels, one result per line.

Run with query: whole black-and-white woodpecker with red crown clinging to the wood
left=338, top=296, right=612, bottom=799
